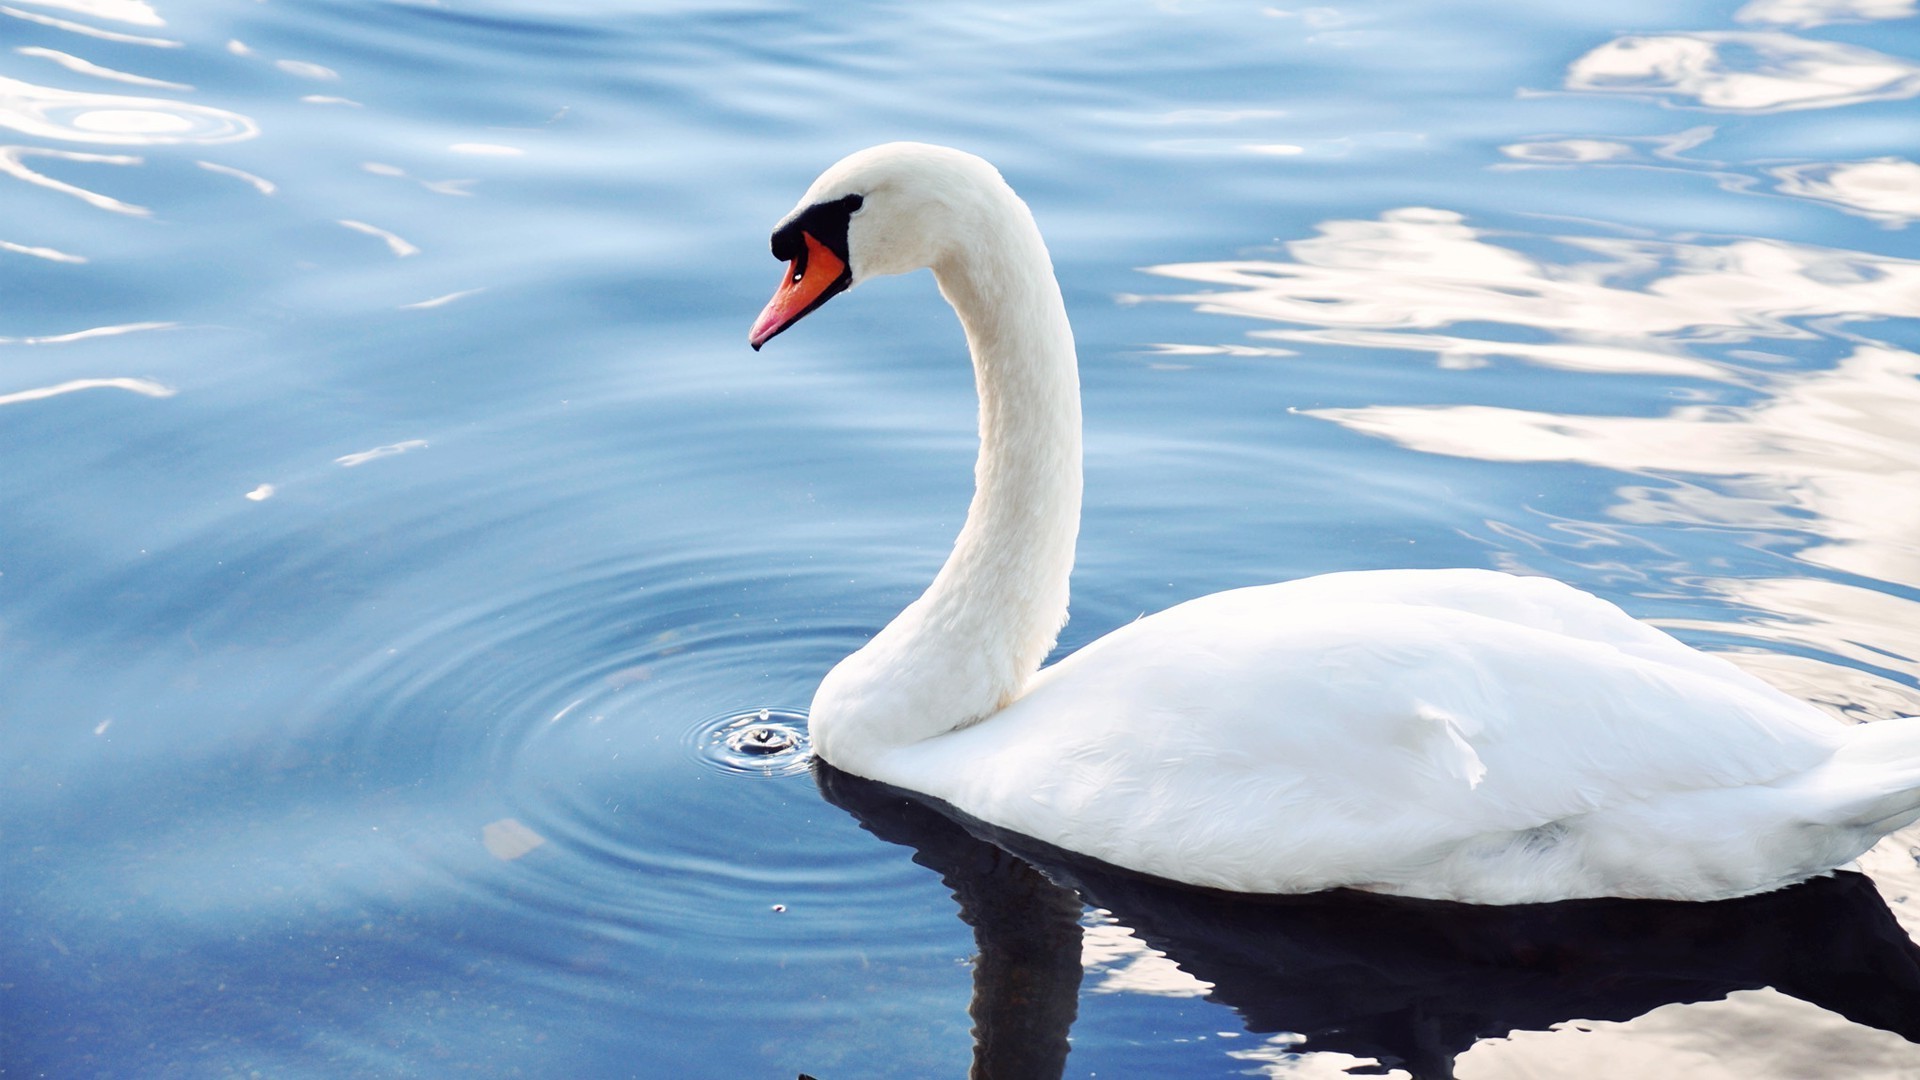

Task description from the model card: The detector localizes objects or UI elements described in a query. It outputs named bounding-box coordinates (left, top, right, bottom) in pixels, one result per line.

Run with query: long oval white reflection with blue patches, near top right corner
left=1567, top=31, right=1920, bottom=113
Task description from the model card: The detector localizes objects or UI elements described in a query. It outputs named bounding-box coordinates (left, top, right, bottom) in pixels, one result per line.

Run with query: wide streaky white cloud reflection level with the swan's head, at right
left=1148, top=208, right=1920, bottom=379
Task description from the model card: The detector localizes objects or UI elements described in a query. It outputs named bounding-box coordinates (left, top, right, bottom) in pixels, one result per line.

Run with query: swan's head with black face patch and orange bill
left=747, top=142, right=1012, bottom=348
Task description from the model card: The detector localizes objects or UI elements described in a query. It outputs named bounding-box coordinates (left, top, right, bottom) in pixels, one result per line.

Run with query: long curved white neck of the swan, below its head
left=812, top=192, right=1081, bottom=773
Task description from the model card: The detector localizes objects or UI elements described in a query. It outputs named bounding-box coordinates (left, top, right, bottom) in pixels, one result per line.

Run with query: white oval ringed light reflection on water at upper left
left=0, top=77, right=259, bottom=146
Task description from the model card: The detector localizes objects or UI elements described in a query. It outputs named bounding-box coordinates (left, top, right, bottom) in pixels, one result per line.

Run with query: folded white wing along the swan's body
left=897, top=571, right=1841, bottom=892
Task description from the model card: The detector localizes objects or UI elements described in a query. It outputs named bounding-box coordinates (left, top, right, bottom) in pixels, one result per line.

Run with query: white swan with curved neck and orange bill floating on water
left=749, top=142, right=1920, bottom=903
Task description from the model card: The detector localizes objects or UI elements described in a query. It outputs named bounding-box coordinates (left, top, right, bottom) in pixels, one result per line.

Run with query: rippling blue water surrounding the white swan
left=0, top=0, right=1920, bottom=1080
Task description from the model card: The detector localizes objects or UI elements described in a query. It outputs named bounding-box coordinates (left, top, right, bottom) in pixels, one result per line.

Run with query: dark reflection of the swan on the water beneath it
left=814, top=763, right=1920, bottom=1078
